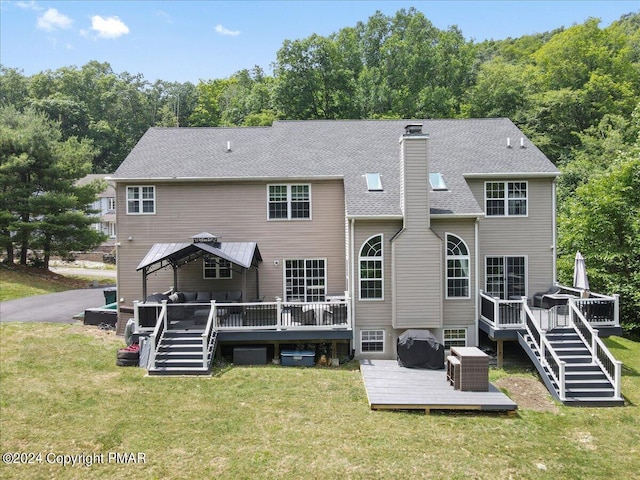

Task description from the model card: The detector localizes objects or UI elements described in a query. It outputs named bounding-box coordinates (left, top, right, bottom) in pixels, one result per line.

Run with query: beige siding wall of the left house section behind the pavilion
left=117, top=180, right=347, bottom=305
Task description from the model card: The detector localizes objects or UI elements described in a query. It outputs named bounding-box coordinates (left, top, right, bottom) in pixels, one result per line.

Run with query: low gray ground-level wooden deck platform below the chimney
left=360, top=360, right=518, bottom=413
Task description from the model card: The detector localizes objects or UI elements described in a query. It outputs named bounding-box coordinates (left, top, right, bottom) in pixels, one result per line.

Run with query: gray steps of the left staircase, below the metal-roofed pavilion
left=148, top=328, right=217, bottom=375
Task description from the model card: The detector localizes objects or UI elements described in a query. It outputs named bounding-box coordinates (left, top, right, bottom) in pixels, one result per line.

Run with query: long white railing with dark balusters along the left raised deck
left=134, top=299, right=352, bottom=332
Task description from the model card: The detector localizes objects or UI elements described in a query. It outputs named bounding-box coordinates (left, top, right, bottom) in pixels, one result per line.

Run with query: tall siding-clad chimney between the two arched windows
left=392, top=136, right=443, bottom=328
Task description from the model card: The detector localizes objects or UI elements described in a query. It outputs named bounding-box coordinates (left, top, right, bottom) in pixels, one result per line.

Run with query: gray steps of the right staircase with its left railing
left=518, top=327, right=624, bottom=407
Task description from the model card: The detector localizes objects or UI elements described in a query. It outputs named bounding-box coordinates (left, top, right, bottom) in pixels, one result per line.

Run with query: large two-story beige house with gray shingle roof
left=111, top=118, right=624, bottom=404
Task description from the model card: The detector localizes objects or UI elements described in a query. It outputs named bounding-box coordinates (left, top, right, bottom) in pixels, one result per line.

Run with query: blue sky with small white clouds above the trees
left=0, top=0, right=640, bottom=84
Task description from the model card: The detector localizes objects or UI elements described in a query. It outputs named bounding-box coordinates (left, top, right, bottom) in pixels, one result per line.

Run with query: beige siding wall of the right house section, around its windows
left=469, top=177, right=555, bottom=296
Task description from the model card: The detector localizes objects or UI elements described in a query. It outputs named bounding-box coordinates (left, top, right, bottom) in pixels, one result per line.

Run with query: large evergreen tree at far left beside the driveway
left=0, top=105, right=104, bottom=268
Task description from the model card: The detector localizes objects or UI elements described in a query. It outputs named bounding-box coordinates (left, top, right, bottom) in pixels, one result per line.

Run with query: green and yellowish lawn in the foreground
left=0, top=323, right=640, bottom=480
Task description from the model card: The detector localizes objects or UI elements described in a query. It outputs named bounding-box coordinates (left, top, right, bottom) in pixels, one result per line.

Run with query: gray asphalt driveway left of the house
left=0, top=288, right=110, bottom=323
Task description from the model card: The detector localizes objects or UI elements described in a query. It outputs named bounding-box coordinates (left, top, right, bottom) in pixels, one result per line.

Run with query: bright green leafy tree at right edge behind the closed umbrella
left=558, top=135, right=640, bottom=333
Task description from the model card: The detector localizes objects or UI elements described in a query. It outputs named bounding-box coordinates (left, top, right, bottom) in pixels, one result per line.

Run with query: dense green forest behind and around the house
left=0, top=8, right=640, bottom=332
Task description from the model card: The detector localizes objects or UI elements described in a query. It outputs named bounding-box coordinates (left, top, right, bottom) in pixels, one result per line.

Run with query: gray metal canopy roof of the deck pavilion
left=136, top=242, right=262, bottom=273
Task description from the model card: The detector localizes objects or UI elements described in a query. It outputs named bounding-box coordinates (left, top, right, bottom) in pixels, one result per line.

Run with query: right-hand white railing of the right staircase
left=569, top=299, right=622, bottom=398
